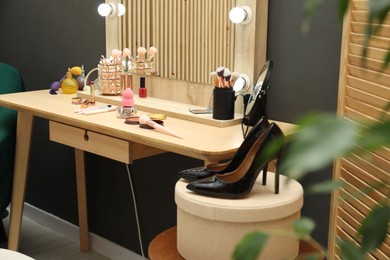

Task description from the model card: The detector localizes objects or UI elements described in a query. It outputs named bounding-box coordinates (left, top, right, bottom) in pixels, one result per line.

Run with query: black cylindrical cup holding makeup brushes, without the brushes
left=213, top=88, right=235, bottom=120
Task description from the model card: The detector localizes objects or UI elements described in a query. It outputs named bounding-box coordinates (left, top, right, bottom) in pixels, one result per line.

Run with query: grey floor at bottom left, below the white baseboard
left=0, top=217, right=110, bottom=260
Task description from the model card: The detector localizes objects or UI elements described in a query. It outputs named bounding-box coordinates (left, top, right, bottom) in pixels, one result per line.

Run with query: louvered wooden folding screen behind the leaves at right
left=328, top=0, right=390, bottom=259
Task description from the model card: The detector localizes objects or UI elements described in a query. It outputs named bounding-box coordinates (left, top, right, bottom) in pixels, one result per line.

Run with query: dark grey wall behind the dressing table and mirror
left=0, top=0, right=340, bottom=253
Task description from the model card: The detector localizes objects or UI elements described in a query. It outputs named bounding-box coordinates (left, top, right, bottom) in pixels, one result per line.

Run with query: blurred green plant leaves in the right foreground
left=233, top=0, right=390, bottom=260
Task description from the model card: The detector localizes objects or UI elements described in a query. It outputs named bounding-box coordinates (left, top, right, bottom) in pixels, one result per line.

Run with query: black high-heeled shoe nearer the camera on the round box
left=187, top=123, right=284, bottom=199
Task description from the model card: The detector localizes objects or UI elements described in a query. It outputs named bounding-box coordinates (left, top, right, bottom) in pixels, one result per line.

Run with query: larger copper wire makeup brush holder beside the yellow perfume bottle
left=98, top=64, right=124, bottom=96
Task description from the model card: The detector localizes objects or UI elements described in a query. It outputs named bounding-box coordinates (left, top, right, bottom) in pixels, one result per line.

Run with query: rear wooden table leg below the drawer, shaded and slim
left=74, top=148, right=89, bottom=252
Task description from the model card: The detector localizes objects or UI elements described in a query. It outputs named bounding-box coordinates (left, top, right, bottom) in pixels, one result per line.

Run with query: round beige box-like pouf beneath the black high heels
left=175, top=172, right=303, bottom=260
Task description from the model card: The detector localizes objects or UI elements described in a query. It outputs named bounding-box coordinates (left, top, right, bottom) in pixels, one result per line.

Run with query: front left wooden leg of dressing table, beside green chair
left=8, top=112, right=34, bottom=251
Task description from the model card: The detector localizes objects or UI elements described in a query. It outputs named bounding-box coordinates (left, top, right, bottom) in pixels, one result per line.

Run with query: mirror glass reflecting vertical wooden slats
left=122, top=0, right=236, bottom=84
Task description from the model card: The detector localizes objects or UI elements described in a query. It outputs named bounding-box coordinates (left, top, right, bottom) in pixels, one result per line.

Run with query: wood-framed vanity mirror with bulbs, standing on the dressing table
left=106, top=0, right=268, bottom=108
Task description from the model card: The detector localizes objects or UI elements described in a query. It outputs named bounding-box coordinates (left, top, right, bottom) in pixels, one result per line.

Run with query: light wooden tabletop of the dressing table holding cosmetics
left=0, top=90, right=293, bottom=161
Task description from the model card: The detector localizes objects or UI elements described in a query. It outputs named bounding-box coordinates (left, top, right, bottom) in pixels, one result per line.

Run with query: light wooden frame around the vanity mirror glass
left=106, top=0, right=268, bottom=110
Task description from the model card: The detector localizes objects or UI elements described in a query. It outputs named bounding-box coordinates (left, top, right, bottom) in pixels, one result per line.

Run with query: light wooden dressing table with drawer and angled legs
left=0, top=90, right=293, bottom=251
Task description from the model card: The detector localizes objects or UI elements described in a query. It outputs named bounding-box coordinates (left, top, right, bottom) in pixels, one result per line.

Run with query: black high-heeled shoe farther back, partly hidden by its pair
left=178, top=118, right=269, bottom=181
